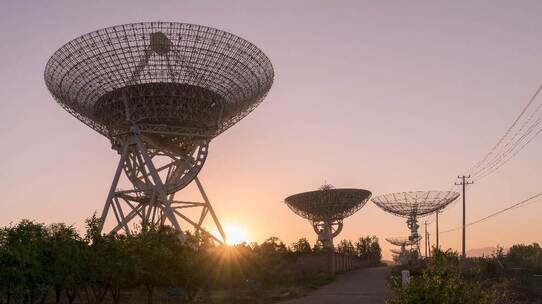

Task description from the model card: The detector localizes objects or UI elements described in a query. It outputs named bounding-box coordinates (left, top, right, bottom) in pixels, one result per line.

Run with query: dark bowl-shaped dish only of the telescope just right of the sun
left=285, top=188, right=371, bottom=222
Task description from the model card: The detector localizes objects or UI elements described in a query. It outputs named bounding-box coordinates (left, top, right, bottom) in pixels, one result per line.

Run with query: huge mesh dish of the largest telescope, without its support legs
left=45, top=22, right=273, bottom=150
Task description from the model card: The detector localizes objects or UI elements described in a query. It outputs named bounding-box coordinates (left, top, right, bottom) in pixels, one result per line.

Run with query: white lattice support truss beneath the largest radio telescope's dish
left=100, top=132, right=226, bottom=244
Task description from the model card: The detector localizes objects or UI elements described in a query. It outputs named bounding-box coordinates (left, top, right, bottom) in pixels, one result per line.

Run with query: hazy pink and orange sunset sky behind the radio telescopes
left=0, top=0, right=542, bottom=258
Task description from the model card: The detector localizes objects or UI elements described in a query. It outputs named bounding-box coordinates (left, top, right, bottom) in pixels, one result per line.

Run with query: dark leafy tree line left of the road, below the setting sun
left=0, top=216, right=381, bottom=304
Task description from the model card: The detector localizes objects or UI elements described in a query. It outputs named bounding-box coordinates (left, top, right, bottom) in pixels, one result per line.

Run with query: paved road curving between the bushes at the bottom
left=282, top=267, right=390, bottom=304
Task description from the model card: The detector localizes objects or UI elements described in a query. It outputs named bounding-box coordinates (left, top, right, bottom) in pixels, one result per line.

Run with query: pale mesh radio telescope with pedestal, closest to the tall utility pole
left=372, top=191, right=459, bottom=253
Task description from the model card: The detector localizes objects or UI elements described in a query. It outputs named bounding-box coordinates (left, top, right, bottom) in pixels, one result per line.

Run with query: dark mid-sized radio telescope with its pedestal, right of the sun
left=285, top=185, right=371, bottom=250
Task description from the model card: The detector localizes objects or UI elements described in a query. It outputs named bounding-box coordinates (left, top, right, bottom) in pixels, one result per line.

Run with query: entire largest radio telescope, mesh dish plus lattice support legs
left=45, top=22, right=273, bottom=242
